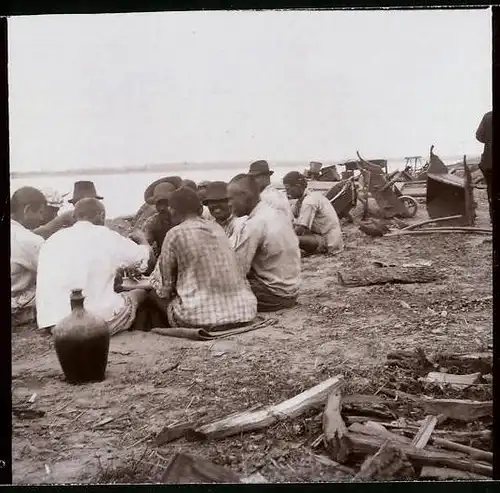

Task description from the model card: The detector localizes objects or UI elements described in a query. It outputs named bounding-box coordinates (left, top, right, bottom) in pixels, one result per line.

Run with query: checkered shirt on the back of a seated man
left=153, top=217, right=257, bottom=327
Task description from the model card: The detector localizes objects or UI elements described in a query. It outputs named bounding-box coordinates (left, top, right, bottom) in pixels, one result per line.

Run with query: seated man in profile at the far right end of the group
left=283, top=171, right=344, bottom=254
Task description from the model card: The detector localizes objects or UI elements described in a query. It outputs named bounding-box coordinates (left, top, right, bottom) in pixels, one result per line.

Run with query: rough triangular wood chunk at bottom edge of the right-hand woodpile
left=354, top=440, right=415, bottom=480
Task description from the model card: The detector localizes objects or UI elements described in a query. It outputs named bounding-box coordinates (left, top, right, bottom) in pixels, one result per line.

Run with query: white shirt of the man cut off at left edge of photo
left=10, top=219, right=45, bottom=296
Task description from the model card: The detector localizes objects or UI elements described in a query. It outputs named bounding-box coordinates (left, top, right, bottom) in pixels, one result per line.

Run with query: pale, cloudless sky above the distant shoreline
left=8, top=9, right=492, bottom=171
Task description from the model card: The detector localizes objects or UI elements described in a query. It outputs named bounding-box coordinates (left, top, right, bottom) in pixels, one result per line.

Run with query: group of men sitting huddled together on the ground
left=11, top=161, right=343, bottom=335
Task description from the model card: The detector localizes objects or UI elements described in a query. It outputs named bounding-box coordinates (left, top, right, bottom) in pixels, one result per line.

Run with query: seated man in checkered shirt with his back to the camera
left=150, top=188, right=257, bottom=330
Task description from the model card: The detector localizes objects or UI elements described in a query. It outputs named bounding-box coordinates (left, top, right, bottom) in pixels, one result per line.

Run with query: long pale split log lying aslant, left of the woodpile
left=192, top=375, right=344, bottom=439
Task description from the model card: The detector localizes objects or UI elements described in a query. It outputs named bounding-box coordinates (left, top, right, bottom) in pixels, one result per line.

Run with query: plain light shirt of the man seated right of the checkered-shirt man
left=235, top=201, right=300, bottom=297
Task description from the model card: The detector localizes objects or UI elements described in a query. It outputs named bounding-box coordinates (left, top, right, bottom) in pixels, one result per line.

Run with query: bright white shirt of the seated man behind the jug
left=36, top=221, right=149, bottom=328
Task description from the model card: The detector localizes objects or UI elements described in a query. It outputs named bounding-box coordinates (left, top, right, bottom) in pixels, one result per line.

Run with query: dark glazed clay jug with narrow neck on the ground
left=52, top=289, right=110, bottom=384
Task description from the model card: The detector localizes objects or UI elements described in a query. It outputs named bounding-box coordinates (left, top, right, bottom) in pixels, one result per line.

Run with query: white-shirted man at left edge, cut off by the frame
left=10, top=187, right=47, bottom=325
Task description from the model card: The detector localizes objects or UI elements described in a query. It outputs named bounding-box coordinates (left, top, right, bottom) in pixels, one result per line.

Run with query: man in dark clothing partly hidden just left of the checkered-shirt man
left=141, top=182, right=176, bottom=270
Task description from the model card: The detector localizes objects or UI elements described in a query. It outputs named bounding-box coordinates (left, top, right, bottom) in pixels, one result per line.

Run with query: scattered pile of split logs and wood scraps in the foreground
left=154, top=350, right=493, bottom=483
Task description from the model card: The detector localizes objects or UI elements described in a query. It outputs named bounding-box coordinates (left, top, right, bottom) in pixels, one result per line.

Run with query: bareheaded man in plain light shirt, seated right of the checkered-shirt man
left=227, top=174, right=300, bottom=312
